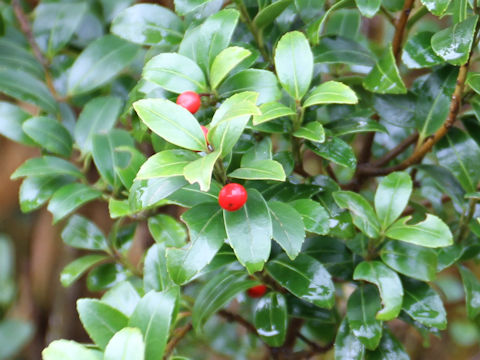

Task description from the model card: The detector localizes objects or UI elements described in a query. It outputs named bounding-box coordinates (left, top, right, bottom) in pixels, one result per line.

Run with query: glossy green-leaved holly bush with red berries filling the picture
left=0, top=0, right=480, bottom=360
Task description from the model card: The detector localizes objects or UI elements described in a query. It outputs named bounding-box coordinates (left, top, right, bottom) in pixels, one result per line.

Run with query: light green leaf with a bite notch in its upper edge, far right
left=385, top=214, right=453, bottom=248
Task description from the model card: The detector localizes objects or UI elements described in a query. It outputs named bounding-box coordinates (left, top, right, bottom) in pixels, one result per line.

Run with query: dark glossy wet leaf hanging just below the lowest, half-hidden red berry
left=255, top=292, right=288, bottom=347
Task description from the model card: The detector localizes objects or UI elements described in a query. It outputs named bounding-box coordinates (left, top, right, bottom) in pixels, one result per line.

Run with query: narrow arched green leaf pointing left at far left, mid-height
left=10, top=156, right=84, bottom=179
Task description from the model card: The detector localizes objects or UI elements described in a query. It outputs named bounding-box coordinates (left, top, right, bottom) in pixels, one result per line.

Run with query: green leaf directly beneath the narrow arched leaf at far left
left=19, top=175, right=73, bottom=213
